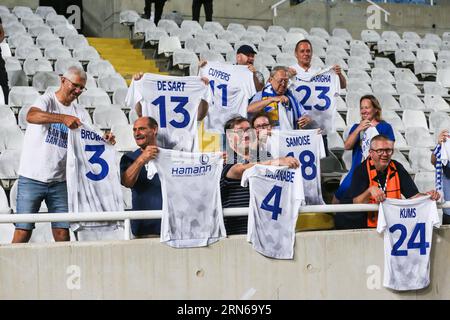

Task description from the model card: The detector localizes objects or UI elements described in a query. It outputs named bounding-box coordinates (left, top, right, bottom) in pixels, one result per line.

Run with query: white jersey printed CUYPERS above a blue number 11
left=199, top=62, right=256, bottom=133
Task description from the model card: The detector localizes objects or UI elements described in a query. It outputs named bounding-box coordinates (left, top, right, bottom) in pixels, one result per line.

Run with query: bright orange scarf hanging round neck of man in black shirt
left=367, top=158, right=402, bottom=228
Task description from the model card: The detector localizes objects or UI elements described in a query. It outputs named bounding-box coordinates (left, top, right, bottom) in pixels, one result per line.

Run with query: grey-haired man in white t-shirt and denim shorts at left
left=12, top=67, right=114, bottom=243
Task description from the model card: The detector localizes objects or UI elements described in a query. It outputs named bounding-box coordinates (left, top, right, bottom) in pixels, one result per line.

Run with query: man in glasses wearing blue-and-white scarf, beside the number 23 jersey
left=247, top=66, right=311, bottom=130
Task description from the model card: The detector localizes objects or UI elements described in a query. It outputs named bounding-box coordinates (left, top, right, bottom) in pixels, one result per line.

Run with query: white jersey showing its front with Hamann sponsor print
left=149, top=149, right=226, bottom=248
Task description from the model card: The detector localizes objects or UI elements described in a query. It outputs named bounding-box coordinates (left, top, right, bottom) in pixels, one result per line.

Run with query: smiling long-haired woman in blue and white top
left=333, top=95, right=395, bottom=204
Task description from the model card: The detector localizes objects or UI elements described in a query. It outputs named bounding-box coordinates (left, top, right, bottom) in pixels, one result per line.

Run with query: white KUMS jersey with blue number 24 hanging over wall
left=377, top=197, right=440, bottom=290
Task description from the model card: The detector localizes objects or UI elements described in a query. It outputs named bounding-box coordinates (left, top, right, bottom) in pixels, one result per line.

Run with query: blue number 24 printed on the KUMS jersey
left=389, top=223, right=430, bottom=257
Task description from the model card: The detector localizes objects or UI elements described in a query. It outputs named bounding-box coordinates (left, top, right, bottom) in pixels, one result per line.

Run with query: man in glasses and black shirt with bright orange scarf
left=337, top=135, right=439, bottom=228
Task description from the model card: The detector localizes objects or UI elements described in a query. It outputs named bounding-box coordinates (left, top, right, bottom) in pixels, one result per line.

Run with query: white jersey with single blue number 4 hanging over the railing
left=241, top=165, right=305, bottom=259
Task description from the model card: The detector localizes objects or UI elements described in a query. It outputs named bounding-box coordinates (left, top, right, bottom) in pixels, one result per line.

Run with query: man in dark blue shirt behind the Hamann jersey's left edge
left=120, top=117, right=162, bottom=238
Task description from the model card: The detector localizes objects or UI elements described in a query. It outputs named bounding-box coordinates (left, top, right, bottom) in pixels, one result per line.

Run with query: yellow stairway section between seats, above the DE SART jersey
left=87, top=38, right=167, bottom=85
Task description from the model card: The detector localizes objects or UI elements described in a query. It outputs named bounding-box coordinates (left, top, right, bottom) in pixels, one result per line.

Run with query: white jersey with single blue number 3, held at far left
left=66, top=124, right=124, bottom=231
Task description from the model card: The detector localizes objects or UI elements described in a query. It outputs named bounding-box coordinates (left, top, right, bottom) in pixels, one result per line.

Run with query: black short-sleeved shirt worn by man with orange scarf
left=346, top=160, right=419, bottom=199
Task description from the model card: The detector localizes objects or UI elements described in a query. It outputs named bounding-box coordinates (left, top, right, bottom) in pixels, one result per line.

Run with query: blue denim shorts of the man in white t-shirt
left=15, top=177, right=70, bottom=230
